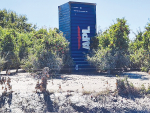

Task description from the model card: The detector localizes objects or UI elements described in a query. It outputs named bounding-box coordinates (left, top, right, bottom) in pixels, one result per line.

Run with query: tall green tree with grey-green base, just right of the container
left=87, top=18, right=130, bottom=70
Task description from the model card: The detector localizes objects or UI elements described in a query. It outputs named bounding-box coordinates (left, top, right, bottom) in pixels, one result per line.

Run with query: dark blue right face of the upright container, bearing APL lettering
left=70, top=2, right=96, bottom=70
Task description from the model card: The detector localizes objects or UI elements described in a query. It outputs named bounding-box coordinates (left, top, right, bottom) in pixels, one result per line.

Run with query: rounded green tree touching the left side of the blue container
left=33, top=29, right=72, bottom=74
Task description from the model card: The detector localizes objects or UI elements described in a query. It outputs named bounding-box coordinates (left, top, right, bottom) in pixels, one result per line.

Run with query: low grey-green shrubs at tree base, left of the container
left=21, top=50, right=70, bottom=74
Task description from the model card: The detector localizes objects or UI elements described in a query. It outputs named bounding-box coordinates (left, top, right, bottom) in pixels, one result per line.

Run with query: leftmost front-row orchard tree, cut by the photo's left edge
left=0, top=29, right=20, bottom=73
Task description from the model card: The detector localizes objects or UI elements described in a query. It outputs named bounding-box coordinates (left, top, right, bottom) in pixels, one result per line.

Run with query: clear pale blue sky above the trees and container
left=0, top=0, right=150, bottom=39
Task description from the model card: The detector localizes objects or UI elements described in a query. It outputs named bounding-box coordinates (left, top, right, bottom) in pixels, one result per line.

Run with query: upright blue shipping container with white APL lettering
left=58, top=1, right=96, bottom=70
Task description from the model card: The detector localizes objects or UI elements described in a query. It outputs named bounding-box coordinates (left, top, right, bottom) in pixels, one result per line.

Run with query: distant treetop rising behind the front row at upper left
left=0, top=9, right=36, bottom=32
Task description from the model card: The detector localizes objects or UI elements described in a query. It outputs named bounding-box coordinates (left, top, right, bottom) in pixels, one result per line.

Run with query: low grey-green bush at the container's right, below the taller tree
left=87, top=48, right=130, bottom=71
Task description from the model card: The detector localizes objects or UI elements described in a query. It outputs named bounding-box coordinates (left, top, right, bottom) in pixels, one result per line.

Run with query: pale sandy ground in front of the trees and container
left=0, top=70, right=150, bottom=113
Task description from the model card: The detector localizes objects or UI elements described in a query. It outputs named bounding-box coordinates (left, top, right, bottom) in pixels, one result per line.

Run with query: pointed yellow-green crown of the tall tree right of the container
left=109, top=18, right=130, bottom=50
